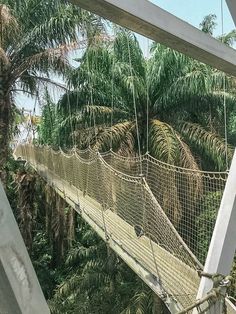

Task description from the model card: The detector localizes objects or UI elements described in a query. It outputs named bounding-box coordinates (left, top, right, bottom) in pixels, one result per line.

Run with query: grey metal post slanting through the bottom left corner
left=0, top=182, right=50, bottom=314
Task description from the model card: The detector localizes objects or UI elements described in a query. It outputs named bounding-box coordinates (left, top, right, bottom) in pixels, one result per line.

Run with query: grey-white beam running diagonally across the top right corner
left=70, top=0, right=236, bottom=76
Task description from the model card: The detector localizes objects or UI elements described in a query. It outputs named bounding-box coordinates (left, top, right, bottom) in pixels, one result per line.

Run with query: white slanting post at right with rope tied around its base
left=197, top=151, right=236, bottom=314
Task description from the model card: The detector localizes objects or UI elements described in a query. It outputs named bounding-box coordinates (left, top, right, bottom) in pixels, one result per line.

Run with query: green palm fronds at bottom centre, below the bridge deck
left=50, top=221, right=169, bottom=314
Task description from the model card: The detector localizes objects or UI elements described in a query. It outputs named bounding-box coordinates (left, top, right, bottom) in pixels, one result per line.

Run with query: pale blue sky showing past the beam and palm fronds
left=17, top=0, right=235, bottom=113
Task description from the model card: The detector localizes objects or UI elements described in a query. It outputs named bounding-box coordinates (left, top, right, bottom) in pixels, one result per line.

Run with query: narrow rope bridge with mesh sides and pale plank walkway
left=15, top=144, right=234, bottom=313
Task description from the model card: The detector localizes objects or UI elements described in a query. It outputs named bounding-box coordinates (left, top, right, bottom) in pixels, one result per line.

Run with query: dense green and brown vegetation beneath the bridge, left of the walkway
left=7, top=159, right=169, bottom=314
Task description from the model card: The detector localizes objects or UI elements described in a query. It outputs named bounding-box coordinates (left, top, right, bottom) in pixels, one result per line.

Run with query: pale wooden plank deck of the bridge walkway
left=36, top=165, right=200, bottom=313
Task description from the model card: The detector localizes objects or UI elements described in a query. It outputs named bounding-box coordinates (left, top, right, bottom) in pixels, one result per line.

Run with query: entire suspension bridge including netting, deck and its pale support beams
left=0, top=0, right=236, bottom=314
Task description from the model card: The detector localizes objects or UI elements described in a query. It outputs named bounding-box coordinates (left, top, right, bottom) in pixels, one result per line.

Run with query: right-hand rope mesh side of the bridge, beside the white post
left=103, top=152, right=228, bottom=264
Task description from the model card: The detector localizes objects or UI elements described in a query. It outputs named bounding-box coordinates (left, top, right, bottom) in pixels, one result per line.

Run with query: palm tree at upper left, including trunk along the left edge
left=0, top=0, right=102, bottom=180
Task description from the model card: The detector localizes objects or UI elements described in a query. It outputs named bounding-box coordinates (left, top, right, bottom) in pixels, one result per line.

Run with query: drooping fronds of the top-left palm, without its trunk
left=1, top=0, right=100, bottom=95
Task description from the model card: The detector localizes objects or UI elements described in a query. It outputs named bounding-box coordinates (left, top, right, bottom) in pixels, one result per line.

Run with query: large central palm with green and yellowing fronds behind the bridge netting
left=53, top=31, right=235, bottom=169
